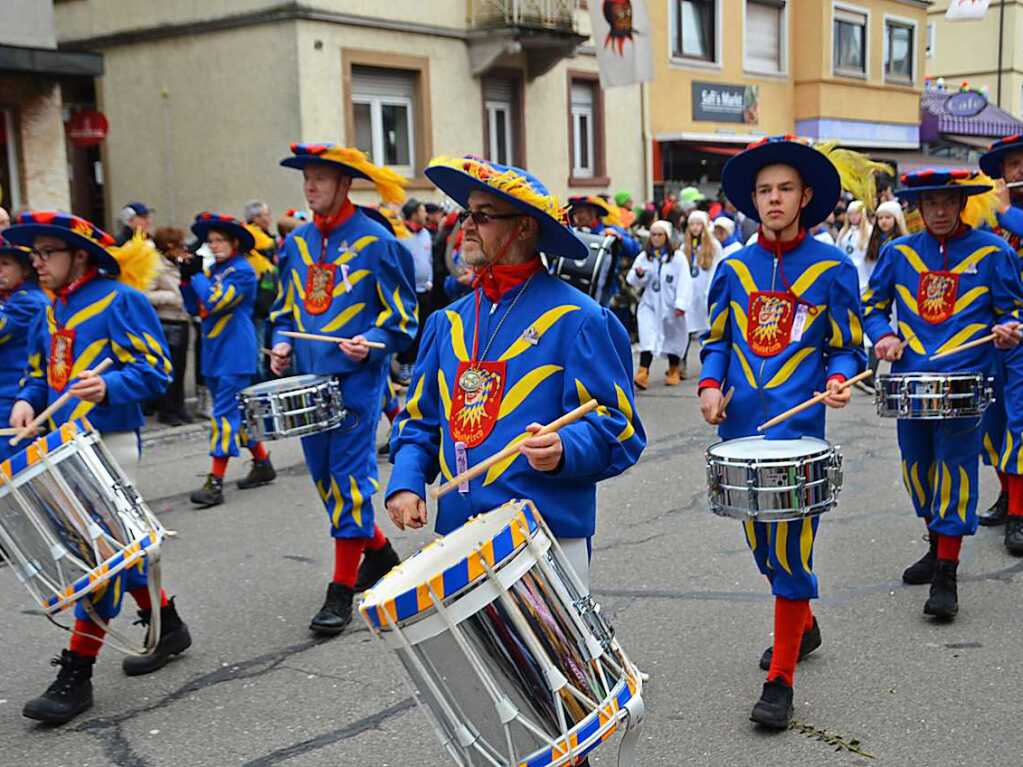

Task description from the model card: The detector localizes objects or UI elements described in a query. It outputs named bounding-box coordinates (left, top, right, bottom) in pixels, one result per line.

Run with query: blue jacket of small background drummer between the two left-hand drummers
left=181, top=255, right=259, bottom=377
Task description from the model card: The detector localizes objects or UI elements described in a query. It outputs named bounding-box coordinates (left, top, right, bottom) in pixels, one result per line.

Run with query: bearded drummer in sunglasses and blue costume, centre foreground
left=387, top=156, right=647, bottom=582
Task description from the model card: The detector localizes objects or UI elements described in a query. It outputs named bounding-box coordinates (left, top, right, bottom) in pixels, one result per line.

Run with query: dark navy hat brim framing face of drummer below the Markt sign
left=721, top=141, right=842, bottom=226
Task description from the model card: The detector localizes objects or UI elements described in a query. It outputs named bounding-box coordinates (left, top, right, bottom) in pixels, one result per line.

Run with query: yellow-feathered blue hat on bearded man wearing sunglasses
left=426, top=156, right=589, bottom=260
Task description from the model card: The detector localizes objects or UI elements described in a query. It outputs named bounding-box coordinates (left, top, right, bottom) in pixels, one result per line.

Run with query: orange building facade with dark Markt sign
left=649, top=0, right=928, bottom=191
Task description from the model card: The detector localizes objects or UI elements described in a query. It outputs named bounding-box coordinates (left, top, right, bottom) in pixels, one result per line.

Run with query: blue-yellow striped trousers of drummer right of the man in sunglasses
left=743, top=516, right=820, bottom=599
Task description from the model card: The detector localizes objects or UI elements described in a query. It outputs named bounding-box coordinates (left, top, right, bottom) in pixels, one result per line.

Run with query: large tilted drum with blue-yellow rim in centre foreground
left=359, top=501, right=643, bottom=767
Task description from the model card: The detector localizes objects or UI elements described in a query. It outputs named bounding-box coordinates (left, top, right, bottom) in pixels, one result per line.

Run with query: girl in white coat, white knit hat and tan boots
left=625, top=221, right=693, bottom=390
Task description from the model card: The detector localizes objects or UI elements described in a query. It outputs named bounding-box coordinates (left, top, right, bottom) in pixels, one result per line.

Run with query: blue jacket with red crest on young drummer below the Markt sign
left=700, top=235, right=866, bottom=440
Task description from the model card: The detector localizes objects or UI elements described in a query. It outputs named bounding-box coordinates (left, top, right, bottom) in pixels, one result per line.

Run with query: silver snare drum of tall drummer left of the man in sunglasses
left=238, top=375, right=346, bottom=442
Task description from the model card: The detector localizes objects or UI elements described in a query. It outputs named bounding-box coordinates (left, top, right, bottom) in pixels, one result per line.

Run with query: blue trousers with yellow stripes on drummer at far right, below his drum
left=898, top=418, right=981, bottom=536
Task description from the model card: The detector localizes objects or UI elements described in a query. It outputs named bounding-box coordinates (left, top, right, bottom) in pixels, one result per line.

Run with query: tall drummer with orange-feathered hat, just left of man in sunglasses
left=270, top=143, right=418, bottom=635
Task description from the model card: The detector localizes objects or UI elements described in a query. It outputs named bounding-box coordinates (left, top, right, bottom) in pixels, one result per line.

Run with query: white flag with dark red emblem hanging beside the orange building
left=589, top=0, right=654, bottom=88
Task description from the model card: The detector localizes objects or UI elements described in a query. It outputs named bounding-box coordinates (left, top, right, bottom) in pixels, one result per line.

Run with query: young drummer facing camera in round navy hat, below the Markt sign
left=699, top=136, right=865, bottom=729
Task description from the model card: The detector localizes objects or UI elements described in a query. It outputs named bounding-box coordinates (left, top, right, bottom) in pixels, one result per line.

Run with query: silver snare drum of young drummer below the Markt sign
left=707, top=437, right=842, bottom=523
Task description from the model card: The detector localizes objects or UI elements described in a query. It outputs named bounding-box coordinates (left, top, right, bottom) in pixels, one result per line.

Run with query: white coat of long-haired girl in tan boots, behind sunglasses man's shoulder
left=625, top=251, right=693, bottom=357
